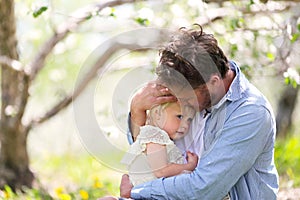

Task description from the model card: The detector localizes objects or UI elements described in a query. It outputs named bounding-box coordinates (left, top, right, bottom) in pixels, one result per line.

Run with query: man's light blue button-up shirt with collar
left=131, top=62, right=278, bottom=200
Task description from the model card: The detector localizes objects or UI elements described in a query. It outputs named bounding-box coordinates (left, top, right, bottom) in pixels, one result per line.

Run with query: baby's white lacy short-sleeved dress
left=121, top=125, right=185, bottom=186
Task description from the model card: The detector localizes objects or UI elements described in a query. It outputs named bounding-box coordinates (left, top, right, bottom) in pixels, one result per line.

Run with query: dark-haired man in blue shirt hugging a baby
left=121, top=27, right=278, bottom=200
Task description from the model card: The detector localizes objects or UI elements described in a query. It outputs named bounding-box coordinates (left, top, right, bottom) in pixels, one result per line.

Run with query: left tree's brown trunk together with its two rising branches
left=0, top=0, right=143, bottom=189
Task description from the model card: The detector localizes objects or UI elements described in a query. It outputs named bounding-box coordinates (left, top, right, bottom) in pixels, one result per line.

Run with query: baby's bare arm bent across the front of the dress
left=146, top=143, right=198, bottom=178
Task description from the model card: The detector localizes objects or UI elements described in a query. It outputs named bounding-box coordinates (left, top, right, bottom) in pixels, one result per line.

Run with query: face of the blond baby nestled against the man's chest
left=161, top=103, right=195, bottom=140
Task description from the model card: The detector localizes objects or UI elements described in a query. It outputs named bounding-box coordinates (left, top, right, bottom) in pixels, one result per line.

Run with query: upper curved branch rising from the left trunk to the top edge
left=28, top=0, right=142, bottom=80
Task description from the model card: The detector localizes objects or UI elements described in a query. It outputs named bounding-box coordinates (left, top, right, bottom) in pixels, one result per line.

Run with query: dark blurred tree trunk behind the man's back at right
left=276, top=85, right=298, bottom=138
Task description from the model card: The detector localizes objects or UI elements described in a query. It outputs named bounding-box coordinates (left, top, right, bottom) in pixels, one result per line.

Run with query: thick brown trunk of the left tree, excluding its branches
left=0, top=0, right=34, bottom=189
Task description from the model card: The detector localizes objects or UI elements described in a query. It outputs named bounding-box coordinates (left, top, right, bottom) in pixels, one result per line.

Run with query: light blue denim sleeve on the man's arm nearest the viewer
left=131, top=105, right=274, bottom=199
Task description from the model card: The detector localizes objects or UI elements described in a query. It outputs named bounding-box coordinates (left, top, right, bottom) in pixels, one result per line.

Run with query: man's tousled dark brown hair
left=156, top=25, right=229, bottom=89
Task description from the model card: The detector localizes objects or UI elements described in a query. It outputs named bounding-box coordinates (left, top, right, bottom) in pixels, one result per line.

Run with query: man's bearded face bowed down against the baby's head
left=174, top=84, right=211, bottom=111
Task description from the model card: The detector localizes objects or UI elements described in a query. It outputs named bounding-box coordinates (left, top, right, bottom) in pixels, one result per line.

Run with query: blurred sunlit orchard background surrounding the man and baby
left=0, top=0, right=300, bottom=199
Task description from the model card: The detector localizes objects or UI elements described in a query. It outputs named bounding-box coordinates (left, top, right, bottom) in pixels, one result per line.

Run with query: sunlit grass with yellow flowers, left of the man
left=0, top=155, right=122, bottom=200
